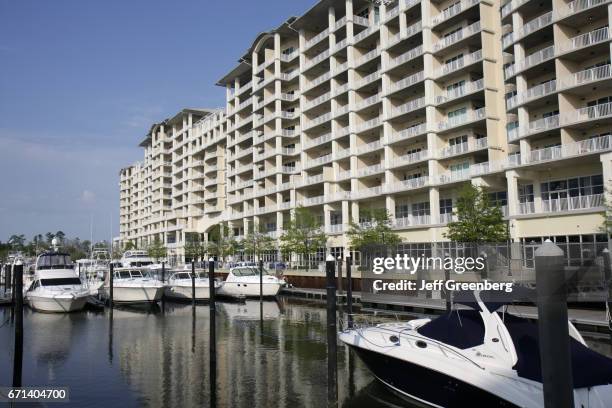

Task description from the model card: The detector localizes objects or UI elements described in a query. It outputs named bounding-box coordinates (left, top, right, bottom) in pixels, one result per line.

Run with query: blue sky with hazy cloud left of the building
left=0, top=0, right=315, bottom=241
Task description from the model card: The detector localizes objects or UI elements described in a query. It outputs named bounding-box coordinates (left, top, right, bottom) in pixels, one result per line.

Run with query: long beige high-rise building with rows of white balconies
left=121, top=0, right=612, bottom=262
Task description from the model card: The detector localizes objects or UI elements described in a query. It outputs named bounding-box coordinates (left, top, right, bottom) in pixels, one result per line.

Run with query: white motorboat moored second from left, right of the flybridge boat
left=104, top=268, right=164, bottom=303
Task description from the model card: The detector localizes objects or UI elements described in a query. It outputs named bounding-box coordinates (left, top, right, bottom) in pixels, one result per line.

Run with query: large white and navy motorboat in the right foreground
left=339, top=293, right=612, bottom=408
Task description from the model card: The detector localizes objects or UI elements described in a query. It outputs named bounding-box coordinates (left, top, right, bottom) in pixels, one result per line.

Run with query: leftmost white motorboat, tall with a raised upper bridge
left=25, top=251, right=90, bottom=313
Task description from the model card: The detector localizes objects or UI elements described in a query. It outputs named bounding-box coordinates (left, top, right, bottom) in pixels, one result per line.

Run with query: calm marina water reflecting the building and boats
left=0, top=298, right=612, bottom=408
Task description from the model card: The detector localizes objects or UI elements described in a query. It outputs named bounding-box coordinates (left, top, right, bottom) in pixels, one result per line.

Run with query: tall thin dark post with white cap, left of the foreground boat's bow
left=325, top=254, right=338, bottom=407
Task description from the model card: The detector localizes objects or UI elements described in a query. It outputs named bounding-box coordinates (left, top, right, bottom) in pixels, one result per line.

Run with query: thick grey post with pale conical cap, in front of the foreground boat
left=535, top=240, right=574, bottom=408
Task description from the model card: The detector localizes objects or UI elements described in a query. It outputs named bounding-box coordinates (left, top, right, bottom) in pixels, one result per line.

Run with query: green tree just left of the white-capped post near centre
left=280, top=207, right=327, bottom=268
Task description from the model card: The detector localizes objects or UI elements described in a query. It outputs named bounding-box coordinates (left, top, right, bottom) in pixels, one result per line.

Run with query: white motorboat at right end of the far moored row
left=219, top=266, right=285, bottom=297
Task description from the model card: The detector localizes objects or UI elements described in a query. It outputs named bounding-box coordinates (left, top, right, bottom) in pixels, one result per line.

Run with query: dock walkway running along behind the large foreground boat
left=281, top=288, right=612, bottom=335
